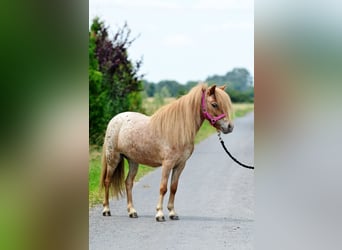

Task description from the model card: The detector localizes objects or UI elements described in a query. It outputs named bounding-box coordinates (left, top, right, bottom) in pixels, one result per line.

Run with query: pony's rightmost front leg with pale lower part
left=167, top=162, right=185, bottom=220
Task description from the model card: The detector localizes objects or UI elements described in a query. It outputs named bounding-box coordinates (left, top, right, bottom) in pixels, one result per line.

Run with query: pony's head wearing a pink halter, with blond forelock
left=202, top=85, right=234, bottom=134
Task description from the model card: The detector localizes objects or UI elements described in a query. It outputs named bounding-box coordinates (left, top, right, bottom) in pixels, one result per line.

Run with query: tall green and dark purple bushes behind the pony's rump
left=89, top=17, right=143, bottom=145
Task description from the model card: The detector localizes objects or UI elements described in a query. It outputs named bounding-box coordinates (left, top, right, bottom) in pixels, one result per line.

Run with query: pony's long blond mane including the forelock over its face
left=150, top=84, right=231, bottom=147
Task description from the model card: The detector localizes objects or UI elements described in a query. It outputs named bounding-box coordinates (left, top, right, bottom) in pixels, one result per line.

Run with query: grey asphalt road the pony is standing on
left=89, top=113, right=254, bottom=250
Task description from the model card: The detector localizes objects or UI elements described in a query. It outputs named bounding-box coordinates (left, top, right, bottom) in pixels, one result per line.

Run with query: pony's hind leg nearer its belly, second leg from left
left=125, top=159, right=139, bottom=218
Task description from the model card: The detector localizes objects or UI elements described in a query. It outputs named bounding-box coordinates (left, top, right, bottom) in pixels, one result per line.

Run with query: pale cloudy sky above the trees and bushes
left=89, top=0, right=254, bottom=83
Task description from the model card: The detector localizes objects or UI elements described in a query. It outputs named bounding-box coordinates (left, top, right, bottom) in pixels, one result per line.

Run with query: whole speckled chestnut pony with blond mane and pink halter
left=101, top=83, right=234, bottom=222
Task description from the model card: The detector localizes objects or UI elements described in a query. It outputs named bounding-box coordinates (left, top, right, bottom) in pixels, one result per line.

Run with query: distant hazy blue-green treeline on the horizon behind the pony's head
left=143, top=68, right=254, bottom=102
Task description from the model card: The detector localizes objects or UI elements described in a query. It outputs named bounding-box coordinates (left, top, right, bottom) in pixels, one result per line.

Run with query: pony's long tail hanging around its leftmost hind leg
left=100, top=145, right=125, bottom=198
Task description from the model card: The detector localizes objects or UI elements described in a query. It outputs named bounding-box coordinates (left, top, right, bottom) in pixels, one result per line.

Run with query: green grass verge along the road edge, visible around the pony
left=89, top=103, right=254, bottom=206
